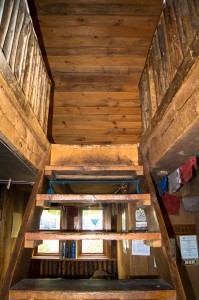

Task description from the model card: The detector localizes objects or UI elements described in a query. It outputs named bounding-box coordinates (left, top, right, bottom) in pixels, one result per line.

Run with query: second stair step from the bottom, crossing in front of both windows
left=25, top=231, right=161, bottom=241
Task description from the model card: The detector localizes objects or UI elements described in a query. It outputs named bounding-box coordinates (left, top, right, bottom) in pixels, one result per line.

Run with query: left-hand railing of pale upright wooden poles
left=0, top=0, right=50, bottom=133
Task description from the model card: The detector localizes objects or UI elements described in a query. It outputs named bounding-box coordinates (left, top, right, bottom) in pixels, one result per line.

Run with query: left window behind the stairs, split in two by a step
left=37, top=209, right=61, bottom=254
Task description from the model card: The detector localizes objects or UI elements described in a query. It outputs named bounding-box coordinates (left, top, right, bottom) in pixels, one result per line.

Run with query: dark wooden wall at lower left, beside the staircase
left=0, top=186, right=30, bottom=289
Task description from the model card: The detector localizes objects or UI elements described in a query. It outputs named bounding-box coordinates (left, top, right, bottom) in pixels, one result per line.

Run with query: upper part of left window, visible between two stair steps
left=39, top=209, right=60, bottom=230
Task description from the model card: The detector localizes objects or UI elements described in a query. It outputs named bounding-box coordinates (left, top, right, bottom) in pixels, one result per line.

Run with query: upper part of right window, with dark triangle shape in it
left=82, top=209, right=103, bottom=230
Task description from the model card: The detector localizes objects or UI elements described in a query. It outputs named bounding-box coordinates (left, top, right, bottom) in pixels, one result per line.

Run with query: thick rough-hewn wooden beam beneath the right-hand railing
left=141, top=49, right=199, bottom=181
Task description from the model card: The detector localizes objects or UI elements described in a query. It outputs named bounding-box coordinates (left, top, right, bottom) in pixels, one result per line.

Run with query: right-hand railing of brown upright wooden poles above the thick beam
left=140, top=0, right=199, bottom=134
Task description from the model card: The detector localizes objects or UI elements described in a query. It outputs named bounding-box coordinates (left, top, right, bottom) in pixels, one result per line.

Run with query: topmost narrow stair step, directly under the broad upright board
left=45, top=164, right=143, bottom=180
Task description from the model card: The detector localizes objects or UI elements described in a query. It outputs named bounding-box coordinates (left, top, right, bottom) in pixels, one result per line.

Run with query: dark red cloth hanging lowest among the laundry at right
left=162, top=193, right=181, bottom=215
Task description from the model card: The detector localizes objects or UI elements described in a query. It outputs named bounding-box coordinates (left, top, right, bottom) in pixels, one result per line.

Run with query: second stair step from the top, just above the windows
left=36, top=194, right=151, bottom=207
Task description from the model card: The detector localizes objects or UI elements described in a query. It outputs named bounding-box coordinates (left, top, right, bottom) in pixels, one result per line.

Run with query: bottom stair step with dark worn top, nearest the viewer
left=9, top=278, right=176, bottom=300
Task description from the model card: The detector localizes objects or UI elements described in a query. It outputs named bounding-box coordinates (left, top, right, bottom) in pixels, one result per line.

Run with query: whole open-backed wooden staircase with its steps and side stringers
left=5, top=145, right=185, bottom=300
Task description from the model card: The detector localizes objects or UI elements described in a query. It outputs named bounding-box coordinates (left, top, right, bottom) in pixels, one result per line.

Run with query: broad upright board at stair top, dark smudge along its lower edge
left=51, top=144, right=138, bottom=167
